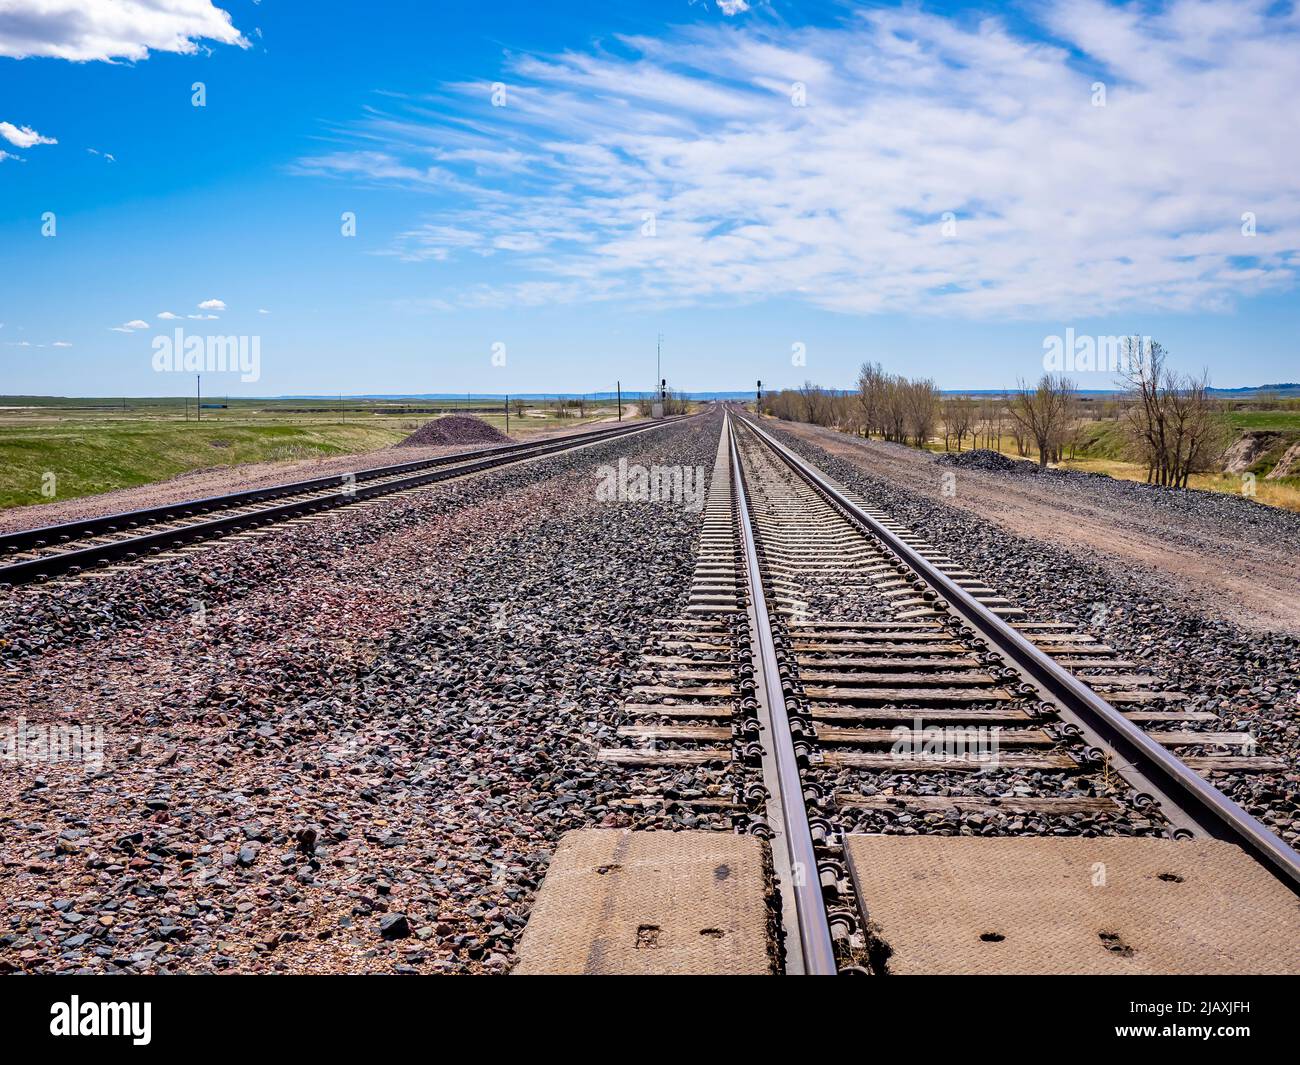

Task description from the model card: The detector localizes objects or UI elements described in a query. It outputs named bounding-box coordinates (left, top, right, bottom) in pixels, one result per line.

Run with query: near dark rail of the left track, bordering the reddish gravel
left=0, top=421, right=675, bottom=585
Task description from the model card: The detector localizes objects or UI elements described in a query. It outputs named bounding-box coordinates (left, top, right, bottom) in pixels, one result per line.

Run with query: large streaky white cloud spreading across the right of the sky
left=299, top=0, right=1300, bottom=316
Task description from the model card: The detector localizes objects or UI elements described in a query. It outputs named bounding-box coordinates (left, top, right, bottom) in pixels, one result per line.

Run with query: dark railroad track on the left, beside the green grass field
left=0, top=421, right=686, bottom=586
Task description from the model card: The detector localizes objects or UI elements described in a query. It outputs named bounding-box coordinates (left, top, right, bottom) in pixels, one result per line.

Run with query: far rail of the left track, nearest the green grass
left=0, top=424, right=681, bottom=553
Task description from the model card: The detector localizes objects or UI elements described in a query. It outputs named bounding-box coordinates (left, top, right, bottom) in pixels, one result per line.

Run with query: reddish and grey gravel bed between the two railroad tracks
left=0, top=420, right=718, bottom=973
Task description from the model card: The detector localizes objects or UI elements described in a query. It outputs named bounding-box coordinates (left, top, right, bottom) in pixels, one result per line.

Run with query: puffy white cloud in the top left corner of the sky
left=0, top=0, right=248, bottom=62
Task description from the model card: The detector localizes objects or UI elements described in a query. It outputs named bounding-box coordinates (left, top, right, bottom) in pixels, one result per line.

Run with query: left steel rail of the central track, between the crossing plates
left=727, top=415, right=839, bottom=977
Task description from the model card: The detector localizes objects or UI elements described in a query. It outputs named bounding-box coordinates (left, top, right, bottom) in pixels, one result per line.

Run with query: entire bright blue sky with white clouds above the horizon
left=0, top=0, right=1300, bottom=395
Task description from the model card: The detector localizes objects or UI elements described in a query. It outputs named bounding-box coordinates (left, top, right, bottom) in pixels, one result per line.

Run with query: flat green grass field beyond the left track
left=0, top=397, right=631, bottom=508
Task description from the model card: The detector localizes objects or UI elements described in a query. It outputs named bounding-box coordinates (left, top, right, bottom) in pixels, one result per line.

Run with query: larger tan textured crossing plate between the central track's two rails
left=846, top=835, right=1300, bottom=975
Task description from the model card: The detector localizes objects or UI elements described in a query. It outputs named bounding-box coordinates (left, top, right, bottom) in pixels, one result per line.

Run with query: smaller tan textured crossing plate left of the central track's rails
left=515, top=828, right=775, bottom=975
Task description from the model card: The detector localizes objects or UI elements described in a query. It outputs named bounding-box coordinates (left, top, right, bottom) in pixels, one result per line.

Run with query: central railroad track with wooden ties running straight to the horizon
left=598, top=412, right=1300, bottom=974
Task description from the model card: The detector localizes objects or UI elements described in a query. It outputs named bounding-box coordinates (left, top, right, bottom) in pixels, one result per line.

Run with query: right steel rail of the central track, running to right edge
left=738, top=419, right=1300, bottom=895
